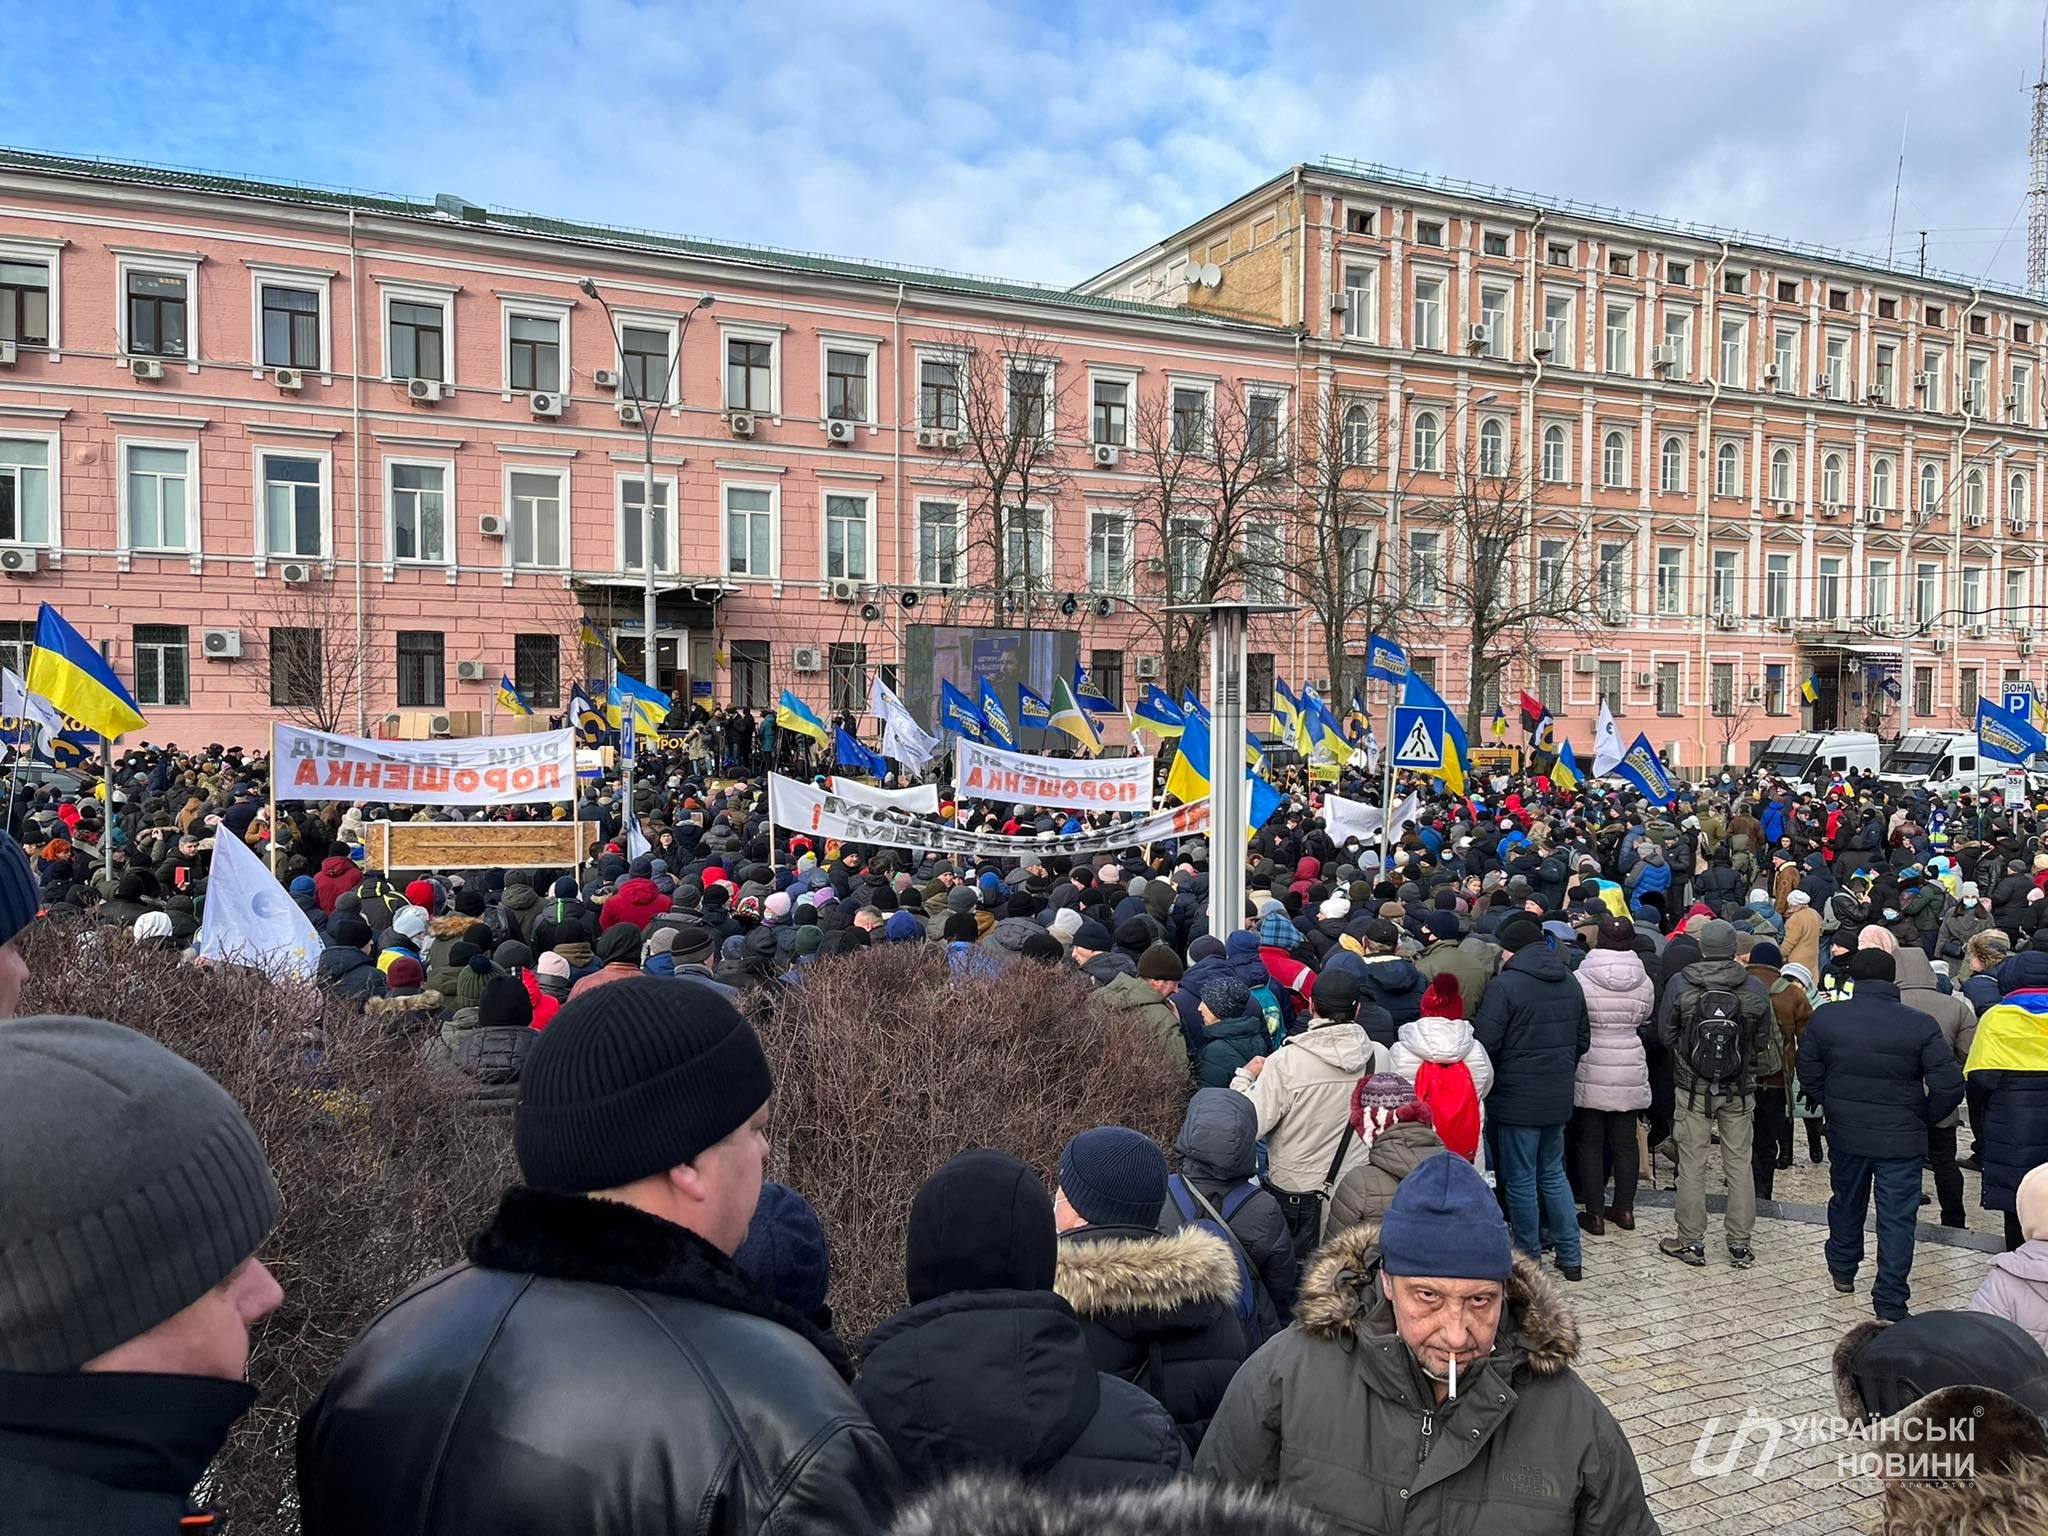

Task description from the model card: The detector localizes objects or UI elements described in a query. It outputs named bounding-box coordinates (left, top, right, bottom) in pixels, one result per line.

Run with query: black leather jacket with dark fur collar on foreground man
left=299, top=1188, right=897, bottom=1536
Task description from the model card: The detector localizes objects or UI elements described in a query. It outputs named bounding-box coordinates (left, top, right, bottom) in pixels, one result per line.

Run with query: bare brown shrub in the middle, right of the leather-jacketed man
left=762, top=944, right=1188, bottom=1346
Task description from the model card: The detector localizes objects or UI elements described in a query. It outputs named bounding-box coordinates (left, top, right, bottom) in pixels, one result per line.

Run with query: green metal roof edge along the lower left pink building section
left=0, top=147, right=1290, bottom=336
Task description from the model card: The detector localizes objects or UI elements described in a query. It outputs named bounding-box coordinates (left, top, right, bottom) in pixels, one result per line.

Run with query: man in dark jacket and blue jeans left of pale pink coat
left=1473, top=911, right=1593, bottom=1280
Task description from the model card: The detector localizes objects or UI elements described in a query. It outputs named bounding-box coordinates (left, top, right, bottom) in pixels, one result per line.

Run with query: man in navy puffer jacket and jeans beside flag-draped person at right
left=1798, top=950, right=1962, bottom=1319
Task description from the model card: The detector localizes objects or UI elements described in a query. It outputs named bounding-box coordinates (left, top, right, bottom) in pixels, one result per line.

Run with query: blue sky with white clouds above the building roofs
left=0, top=0, right=2042, bottom=283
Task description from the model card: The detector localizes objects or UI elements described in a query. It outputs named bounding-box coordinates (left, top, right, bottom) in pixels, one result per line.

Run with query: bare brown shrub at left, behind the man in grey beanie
left=23, top=924, right=516, bottom=1534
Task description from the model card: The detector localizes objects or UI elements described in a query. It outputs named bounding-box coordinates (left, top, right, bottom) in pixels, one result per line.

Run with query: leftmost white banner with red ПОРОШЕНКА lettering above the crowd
left=270, top=725, right=575, bottom=805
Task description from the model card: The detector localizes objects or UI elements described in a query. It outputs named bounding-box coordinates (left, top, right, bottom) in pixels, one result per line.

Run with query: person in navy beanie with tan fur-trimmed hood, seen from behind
left=1053, top=1126, right=1251, bottom=1454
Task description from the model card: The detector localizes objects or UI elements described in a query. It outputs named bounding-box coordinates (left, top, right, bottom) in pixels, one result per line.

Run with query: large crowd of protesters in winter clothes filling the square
left=0, top=713, right=2048, bottom=1536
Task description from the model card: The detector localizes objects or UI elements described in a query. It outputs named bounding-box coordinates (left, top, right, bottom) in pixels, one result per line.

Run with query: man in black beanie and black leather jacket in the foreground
left=299, top=977, right=897, bottom=1536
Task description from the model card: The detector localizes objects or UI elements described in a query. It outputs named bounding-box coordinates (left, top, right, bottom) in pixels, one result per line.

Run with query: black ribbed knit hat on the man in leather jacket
left=512, top=977, right=774, bottom=1194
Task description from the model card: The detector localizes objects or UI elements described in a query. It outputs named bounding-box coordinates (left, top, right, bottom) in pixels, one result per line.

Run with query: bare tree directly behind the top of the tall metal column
left=1122, top=385, right=1290, bottom=698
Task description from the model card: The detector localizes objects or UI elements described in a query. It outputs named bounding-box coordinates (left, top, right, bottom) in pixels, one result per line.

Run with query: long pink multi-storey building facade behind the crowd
left=0, top=154, right=2048, bottom=766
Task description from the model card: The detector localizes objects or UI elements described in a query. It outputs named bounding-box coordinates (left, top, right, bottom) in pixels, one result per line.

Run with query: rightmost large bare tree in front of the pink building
left=1407, top=438, right=1597, bottom=737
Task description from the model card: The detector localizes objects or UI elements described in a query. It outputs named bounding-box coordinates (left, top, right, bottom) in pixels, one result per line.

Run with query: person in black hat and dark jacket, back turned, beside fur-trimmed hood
left=854, top=1155, right=1187, bottom=1493
